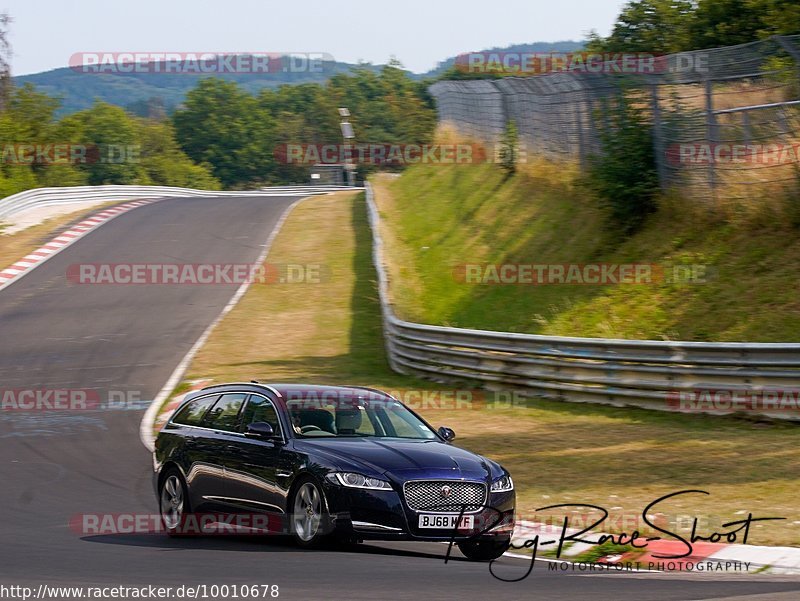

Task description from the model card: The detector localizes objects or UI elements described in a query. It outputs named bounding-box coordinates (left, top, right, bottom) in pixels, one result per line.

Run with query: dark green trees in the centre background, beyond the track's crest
left=172, top=62, right=436, bottom=187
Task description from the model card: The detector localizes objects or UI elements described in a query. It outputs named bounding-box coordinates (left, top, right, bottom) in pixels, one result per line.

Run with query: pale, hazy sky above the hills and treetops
left=0, top=0, right=624, bottom=75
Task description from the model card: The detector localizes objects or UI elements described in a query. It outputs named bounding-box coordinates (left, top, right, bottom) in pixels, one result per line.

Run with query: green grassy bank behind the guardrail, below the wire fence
left=376, top=165, right=800, bottom=342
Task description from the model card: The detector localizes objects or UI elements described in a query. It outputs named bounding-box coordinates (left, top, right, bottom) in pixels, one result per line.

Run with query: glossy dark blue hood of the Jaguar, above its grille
left=297, top=438, right=499, bottom=481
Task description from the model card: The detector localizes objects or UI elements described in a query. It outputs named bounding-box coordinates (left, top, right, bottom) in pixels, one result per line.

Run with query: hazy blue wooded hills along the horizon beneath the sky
left=13, top=41, right=582, bottom=116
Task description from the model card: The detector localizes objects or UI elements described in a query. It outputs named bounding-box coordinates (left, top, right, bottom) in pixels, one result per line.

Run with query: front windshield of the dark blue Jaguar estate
left=287, top=398, right=436, bottom=440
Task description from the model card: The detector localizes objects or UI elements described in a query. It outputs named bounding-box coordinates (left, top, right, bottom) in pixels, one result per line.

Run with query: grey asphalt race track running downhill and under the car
left=0, top=197, right=800, bottom=601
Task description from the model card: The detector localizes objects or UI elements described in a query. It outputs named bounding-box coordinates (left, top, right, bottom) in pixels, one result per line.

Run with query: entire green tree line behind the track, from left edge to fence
left=0, top=63, right=436, bottom=197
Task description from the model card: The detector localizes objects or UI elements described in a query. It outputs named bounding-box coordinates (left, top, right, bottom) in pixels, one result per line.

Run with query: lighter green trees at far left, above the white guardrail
left=0, top=85, right=219, bottom=196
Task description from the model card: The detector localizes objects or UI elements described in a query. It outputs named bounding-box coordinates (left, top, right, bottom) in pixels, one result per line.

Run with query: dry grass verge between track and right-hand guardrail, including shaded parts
left=175, top=194, right=800, bottom=545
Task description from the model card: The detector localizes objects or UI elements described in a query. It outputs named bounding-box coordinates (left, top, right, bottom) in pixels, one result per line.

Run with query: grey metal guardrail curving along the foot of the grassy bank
left=367, top=185, right=800, bottom=419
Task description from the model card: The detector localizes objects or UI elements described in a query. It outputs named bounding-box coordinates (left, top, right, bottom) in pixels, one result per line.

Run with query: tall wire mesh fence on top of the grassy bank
left=430, top=35, right=800, bottom=199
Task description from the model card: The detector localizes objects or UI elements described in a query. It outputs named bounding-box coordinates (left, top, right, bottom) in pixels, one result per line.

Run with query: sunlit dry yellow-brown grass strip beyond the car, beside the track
left=187, top=192, right=366, bottom=382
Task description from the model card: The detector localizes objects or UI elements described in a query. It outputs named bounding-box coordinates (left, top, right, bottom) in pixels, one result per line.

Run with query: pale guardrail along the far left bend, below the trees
left=0, top=186, right=358, bottom=221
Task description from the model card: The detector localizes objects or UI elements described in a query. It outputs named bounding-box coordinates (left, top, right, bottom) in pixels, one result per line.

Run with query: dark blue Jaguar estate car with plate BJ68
left=154, top=382, right=515, bottom=560
